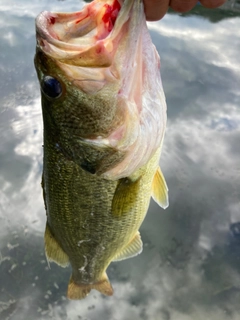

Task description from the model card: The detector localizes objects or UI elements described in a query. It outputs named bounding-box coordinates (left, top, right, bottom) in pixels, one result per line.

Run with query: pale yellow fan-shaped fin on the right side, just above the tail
left=113, top=231, right=142, bottom=261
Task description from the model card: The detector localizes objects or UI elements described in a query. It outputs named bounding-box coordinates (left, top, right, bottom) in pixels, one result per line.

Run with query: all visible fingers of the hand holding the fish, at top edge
left=143, top=0, right=226, bottom=21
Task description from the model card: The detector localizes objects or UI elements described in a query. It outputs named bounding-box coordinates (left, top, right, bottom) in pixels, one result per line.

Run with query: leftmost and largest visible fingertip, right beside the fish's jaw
left=143, top=0, right=169, bottom=21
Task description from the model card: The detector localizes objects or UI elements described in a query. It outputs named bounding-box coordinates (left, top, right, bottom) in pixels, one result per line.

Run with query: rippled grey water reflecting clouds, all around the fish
left=0, top=0, right=240, bottom=320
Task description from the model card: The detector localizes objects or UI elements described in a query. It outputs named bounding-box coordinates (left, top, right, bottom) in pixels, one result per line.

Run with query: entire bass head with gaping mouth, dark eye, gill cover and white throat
left=35, top=0, right=166, bottom=179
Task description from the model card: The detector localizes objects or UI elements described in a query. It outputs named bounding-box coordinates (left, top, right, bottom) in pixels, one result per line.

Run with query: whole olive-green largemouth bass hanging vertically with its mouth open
left=34, top=0, right=168, bottom=299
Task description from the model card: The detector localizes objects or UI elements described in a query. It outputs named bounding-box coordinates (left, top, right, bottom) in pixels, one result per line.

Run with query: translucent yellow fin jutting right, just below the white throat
left=152, top=167, right=168, bottom=209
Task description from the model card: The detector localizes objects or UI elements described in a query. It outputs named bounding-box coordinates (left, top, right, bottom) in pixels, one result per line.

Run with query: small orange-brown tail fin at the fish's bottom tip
left=67, top=273, right=113, bottom=300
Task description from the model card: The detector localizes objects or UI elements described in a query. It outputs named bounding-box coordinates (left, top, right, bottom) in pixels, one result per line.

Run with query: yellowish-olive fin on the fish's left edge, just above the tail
left=44, top=224, right=69, bottom=268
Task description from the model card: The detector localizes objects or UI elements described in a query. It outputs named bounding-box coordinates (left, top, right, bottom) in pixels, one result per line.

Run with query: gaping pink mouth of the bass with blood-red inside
left=36, top=0, right=134, bottom=67
